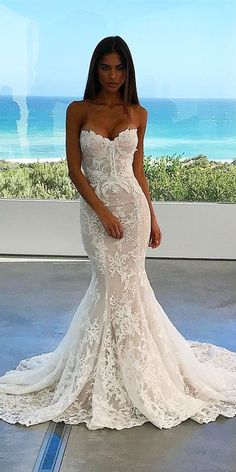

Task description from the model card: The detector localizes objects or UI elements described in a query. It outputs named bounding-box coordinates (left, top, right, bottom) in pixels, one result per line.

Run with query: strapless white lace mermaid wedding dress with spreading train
left=0, top=128, right=236, bottom=430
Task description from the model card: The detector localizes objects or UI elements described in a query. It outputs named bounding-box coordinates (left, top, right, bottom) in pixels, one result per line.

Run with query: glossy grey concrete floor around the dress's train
left=0, top=257, right=236, bottom=472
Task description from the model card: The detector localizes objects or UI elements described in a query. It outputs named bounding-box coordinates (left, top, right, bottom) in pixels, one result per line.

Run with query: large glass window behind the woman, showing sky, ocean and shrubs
left=0, top=0, right=236, bottom=203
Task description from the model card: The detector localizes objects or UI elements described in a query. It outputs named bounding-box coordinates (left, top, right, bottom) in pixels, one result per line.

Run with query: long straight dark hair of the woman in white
left=83, top=36, right=140, bottom=120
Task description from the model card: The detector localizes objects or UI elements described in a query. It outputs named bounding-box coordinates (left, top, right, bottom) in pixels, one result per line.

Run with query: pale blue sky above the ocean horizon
left=0, top=0, right=236, bottom=98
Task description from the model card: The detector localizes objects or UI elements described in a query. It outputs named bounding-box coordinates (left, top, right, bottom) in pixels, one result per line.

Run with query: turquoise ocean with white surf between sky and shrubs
left=0, top=95, right=236, bottom=162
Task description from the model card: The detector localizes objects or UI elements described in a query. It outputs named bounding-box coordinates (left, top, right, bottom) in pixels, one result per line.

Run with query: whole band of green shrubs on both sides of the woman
left=0, top=155, right=236, bottom=203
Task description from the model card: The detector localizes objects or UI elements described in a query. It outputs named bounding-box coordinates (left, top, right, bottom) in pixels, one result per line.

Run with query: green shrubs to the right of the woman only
left=144, top=156, right=236, bottom=203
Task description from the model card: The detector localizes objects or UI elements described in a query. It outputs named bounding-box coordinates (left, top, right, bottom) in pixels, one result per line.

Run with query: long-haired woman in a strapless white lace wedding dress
left=0, top=36, right=236, bottom=430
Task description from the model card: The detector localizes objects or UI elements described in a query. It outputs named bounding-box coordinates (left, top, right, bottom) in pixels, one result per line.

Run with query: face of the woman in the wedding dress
left=98, top=52, right=126, bottom=92
